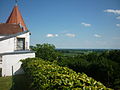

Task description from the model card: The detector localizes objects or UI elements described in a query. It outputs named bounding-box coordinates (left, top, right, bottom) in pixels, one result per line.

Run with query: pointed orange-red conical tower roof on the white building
left=6, top=5, right=28, bottom=30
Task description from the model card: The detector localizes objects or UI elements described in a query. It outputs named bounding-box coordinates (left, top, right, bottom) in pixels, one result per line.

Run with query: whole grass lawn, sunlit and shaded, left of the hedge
left=0, top=75, right=29, bottom=90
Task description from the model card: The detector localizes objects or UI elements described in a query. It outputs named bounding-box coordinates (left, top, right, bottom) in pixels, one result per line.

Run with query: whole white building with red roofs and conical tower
left=0, top=5, right=35, bottom=76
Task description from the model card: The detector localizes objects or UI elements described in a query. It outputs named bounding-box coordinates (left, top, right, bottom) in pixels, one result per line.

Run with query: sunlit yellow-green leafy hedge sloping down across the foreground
left=21, top=58, right=110, bottom=90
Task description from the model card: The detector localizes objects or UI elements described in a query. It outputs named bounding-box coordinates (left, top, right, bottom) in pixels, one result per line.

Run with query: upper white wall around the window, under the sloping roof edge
left=0, top=32, right=30, bottom=53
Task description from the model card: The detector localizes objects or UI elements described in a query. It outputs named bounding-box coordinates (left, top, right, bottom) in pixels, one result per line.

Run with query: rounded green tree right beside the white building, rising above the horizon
left=31, top=44, right=60, bottom=61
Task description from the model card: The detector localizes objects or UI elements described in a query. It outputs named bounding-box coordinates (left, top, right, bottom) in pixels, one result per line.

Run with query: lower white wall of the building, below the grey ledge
left=2, top=53, right=35, bottom=76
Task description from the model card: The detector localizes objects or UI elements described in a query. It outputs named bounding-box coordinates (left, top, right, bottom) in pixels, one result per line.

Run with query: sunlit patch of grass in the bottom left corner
left=0, top=76, right=12, bottom=90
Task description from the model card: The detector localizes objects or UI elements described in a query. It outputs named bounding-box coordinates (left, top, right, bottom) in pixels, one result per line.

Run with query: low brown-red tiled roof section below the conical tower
left=0, top=23, right=23, bottom=35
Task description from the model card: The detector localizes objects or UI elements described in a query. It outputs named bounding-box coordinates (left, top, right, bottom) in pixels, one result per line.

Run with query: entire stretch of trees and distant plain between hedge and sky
left=31, top=44, right=120, bottom=90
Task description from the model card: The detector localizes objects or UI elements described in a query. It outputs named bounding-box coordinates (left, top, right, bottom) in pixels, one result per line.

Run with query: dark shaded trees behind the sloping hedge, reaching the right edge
left=58, top=50, right=120, bottom=89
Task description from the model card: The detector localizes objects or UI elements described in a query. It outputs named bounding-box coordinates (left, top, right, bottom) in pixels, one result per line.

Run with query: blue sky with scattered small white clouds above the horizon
left=0, top=0, right=120, bottom=49
